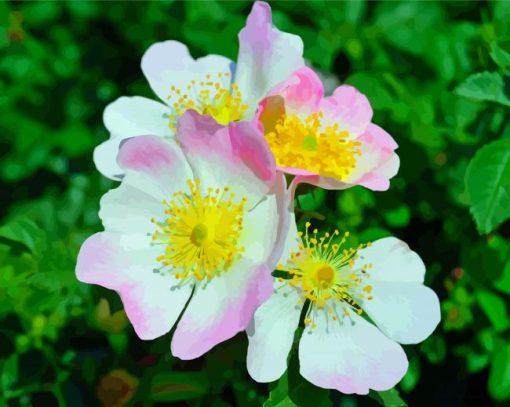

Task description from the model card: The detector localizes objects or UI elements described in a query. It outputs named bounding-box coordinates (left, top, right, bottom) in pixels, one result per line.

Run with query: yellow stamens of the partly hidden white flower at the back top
left=167, top=72, right=248, bottom=130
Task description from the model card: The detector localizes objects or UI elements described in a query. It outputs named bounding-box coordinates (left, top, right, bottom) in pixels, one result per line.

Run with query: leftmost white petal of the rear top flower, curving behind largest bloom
left=94, top=96, right=169, bottom=179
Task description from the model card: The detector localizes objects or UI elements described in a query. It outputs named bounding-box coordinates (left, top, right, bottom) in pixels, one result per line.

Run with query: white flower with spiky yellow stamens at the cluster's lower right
left=247, top=220, right=440, bottom=394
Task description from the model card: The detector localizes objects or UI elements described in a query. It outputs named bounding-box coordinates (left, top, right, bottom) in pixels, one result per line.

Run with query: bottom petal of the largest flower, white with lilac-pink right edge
left=172, top=259, right=273, bottom=360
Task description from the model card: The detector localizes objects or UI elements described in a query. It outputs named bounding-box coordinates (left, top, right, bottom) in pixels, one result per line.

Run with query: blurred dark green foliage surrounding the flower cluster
left=0, top=1, right=510, bottom=407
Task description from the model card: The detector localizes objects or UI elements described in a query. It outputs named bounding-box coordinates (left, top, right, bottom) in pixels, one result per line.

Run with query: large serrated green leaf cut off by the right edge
left=465, top=139, right=510, bottom=233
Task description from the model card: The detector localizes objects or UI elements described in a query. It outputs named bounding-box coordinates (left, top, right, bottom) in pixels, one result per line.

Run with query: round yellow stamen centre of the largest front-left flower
left=152, top=178, right=247, bottom=281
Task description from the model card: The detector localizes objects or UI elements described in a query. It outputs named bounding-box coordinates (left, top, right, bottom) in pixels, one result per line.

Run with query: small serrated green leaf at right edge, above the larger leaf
left=455, top=72, right=510, bottom=106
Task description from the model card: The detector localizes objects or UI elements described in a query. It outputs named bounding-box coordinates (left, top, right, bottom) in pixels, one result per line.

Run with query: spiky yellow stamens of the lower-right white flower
left=278, top=222, right=373, bottom=327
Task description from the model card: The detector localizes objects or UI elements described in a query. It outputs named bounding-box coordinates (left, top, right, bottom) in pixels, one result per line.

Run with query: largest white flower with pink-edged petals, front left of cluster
left=76, top=110, right=289, bottom=359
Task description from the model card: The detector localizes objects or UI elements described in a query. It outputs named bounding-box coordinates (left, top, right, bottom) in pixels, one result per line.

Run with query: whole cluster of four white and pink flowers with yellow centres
left=76, top=2, right=440, bottom=394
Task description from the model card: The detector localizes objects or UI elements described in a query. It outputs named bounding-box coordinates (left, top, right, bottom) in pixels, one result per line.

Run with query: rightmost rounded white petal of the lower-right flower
left=363, top=281, right=441, bottom=345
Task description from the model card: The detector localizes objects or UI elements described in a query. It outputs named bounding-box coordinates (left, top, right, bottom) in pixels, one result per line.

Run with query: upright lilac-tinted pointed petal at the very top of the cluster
left=235, top=1, right=304, bottom=116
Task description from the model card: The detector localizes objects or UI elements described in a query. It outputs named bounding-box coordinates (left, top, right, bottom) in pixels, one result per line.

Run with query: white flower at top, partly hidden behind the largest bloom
left=94, top=1, right=304, bottom=179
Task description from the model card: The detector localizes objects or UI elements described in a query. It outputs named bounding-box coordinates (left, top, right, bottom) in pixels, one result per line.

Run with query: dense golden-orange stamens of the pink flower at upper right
left=262, top=112, right=361, bottom=181
